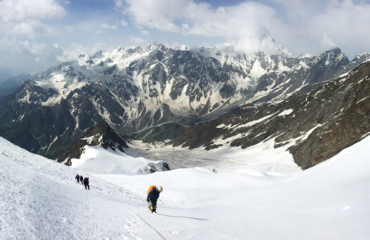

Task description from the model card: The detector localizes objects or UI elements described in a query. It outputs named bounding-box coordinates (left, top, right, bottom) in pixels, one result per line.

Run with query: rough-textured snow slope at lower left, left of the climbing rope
left=0, top=139, right=161, bottom=239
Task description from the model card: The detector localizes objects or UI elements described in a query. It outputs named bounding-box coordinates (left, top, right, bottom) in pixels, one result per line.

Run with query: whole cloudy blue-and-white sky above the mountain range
left=0, top=0, right=370, bottom=79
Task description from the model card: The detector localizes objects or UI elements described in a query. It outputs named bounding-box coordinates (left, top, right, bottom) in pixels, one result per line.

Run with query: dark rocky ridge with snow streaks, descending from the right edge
left=171, top=62, right=370, bottom=169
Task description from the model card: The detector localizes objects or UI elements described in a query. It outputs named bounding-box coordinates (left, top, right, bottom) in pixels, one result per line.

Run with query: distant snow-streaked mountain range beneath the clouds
left=0, top=43, right=369, bottom=158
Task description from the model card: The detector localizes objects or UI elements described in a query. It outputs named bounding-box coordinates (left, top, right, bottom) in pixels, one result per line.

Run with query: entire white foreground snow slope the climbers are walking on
left=0, top=137, right=370, bottom=240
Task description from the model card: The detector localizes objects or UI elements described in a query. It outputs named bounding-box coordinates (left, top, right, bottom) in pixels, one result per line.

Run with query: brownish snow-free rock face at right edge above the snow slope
left=290, top=63, right=370, bottom=168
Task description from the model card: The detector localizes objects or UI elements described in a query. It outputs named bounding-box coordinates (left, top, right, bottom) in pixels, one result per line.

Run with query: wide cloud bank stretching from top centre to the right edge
left=116, top=0, right=370, bottom=55
